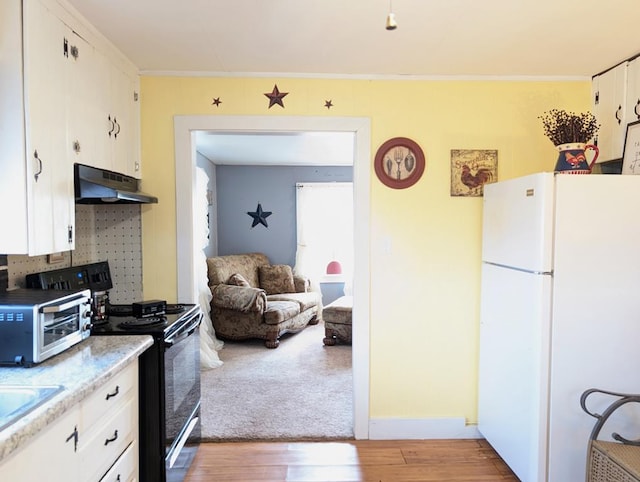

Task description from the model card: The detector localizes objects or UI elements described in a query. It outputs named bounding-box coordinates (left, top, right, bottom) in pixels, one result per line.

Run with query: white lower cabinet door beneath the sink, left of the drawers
left=0, top=408, right=81, bottom=482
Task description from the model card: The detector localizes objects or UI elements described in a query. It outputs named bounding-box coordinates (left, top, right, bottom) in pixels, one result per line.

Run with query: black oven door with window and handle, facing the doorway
left=164, top=310, right=203, bottom=482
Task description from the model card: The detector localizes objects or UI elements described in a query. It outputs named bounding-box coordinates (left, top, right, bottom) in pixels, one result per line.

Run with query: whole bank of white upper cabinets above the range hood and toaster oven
left=0, top=0, right=141, bottom=256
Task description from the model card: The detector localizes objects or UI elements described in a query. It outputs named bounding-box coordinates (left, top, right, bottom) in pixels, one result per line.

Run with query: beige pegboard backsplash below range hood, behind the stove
left=8, top=204, right=143, bottom=304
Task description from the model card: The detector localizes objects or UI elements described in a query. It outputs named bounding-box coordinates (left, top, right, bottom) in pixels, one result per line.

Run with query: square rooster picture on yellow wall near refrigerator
left=451, top=149, right=498, bottom=197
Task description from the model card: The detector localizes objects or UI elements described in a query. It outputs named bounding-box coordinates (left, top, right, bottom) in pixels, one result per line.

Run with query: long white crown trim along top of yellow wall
left=140, top=70, right=592, bottom=82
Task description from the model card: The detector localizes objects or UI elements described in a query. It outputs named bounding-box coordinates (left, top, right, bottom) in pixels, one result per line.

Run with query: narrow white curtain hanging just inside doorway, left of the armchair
left=193, top=167, right=223, bottom=369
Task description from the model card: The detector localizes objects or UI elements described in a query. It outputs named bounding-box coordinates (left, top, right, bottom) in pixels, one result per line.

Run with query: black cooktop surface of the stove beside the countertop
left=91, top=304, right=199, bottom=338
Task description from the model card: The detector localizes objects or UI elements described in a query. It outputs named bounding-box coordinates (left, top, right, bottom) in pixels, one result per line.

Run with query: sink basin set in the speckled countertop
left=0, top=385, right=64, bottom=430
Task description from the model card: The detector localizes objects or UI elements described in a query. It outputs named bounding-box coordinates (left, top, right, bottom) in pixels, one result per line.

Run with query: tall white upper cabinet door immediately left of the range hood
left=23, top=0, right=75, bottom=256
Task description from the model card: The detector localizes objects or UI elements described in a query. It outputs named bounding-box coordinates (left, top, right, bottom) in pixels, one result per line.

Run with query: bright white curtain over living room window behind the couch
left=295, top=182, right=353, bottom=300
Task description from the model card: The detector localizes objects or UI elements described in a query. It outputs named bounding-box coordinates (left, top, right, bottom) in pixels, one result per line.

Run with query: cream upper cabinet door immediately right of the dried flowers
left=593, top=62, right=627, bottom=162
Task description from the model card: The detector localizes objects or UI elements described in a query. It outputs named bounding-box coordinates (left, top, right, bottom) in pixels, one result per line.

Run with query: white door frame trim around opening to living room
left=174, top=115, right=371, bottom=439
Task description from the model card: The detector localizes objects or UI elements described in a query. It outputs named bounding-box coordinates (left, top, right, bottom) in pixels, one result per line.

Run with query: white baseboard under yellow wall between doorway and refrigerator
left=369, top=417, right=483, bottom=440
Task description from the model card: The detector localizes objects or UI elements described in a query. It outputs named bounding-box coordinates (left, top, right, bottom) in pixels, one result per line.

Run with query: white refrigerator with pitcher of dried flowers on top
left=478, top=173, right=640, bottom=482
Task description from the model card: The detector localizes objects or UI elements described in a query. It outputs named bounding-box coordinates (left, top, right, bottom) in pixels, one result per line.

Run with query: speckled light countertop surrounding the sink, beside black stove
left=0, top=335, right=153, bottom=463
